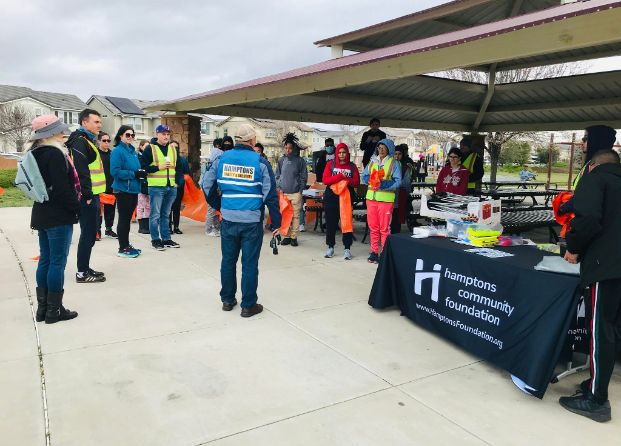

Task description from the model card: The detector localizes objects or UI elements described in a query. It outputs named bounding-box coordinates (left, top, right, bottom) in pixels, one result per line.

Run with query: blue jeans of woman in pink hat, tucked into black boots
left=37, top=225, right=73, bottom=293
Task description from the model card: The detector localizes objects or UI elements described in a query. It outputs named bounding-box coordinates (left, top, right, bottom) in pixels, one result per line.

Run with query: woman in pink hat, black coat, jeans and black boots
left=30, top=115, right=80, bottom=324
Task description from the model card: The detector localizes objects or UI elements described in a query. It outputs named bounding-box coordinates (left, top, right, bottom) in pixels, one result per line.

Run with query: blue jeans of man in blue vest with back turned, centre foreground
left=220, top=220, right=263, bottom=308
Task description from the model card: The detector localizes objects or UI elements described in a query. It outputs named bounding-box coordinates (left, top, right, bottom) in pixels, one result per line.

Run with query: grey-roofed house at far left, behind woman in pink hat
left=0, top=85, right=86, bottom=152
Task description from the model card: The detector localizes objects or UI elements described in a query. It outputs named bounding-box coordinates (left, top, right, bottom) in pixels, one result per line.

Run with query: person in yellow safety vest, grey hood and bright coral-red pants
left=362, top=138, right=401, bottom=263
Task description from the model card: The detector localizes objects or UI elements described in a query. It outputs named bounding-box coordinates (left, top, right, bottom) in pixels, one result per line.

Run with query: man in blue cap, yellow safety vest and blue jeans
left=140, top=124, right=183, bottom=251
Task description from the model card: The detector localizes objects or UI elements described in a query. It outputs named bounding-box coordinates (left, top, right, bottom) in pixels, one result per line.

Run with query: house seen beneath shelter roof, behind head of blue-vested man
left=215, top=116, right=314, bottom=161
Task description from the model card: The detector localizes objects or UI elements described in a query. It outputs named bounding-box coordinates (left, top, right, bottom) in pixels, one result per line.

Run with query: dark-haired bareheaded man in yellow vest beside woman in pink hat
left=66, top=108, right=106, bottom=283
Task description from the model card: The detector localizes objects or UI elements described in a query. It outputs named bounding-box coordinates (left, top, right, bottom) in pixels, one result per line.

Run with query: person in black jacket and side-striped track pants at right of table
left=559, top=150, right=621, bottom=422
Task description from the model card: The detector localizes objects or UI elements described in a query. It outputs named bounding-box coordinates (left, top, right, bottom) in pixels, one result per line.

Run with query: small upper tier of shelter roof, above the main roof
left=315, top=0, right=561, bottom=51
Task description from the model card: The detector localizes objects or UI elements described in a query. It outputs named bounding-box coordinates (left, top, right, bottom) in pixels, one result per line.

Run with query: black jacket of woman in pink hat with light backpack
left=30, top=146, right=80, bottom=229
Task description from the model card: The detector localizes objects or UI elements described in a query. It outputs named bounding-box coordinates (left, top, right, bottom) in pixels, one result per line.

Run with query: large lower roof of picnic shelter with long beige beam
left=148, top=0, right=621, bottom=131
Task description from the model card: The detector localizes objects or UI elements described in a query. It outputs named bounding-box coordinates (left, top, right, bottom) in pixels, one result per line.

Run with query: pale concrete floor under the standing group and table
left=0, top=208, right=621, bottom=446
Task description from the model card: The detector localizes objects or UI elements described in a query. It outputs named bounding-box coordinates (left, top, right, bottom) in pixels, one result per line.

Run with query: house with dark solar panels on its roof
left=86, top=95, right=164, bottom=141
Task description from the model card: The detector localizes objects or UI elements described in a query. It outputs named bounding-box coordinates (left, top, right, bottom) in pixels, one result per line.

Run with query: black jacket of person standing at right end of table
left=566, top=164, right=621, bottom=285
